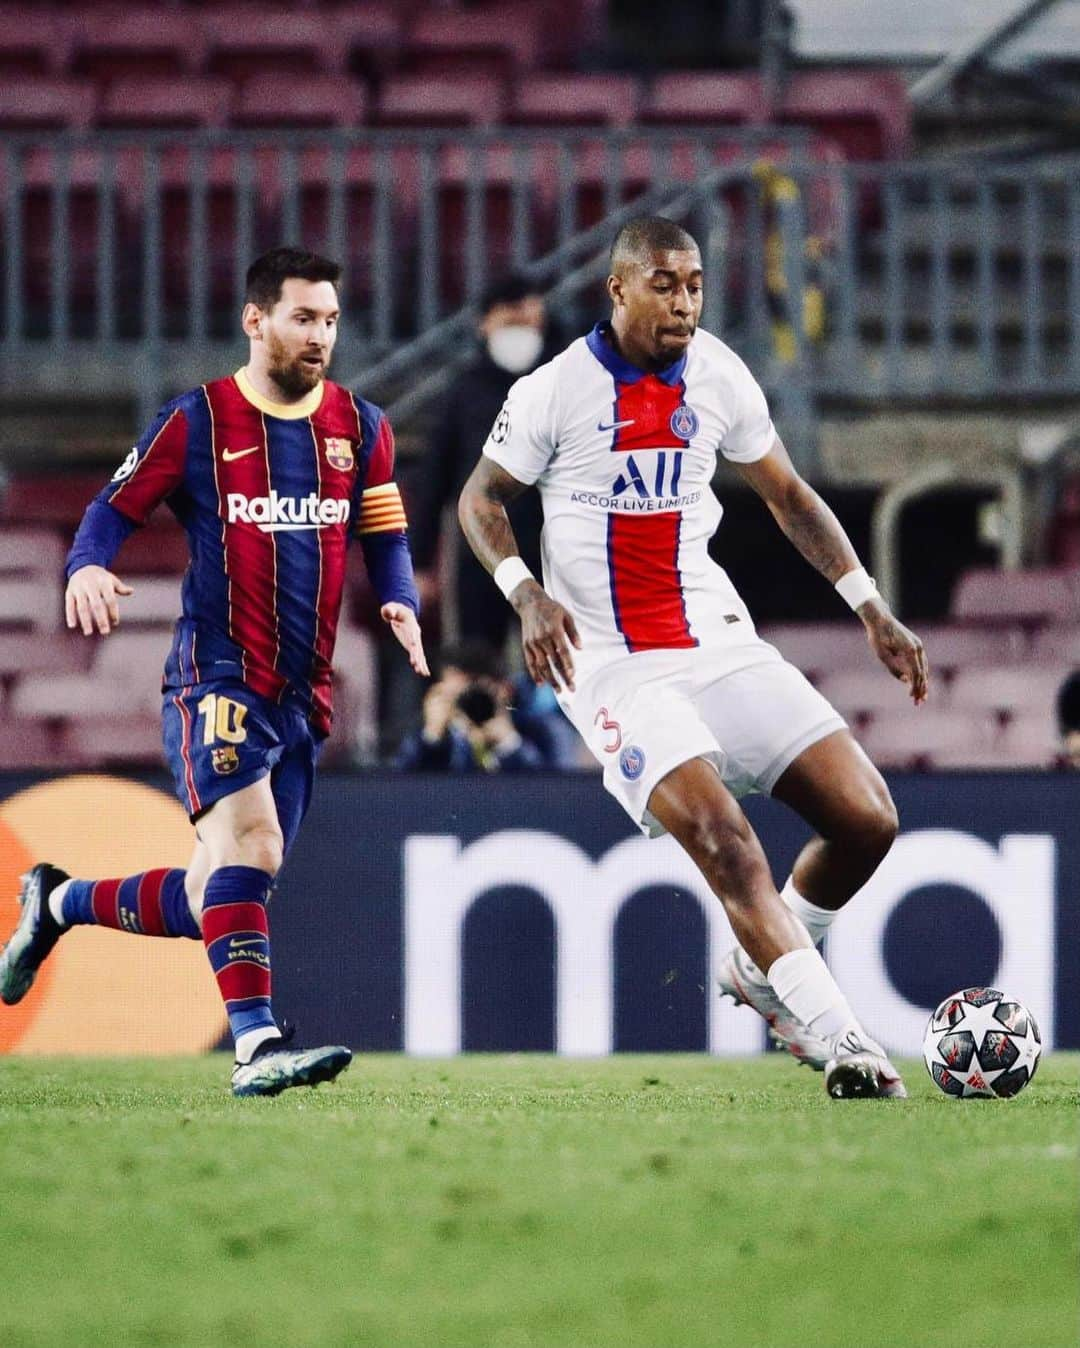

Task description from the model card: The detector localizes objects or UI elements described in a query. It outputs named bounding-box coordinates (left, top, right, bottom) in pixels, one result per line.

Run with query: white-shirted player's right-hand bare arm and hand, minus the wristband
left=736, top=439, right=930, bottom=705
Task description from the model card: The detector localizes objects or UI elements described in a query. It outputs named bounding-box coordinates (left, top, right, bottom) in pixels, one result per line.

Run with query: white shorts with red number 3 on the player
left=560, top=639, right=847, bottom=837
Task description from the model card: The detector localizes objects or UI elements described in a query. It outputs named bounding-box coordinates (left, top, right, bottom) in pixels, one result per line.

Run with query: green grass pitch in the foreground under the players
left=0, top=1054, right=1080, bottom=1348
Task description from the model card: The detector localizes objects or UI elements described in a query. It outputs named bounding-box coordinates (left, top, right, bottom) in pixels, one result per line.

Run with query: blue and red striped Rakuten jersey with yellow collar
left=84, top=371, right=406, bottom=735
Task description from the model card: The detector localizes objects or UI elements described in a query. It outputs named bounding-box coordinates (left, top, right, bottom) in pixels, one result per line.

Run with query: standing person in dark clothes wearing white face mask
left=410, top=275, right=551, bottom=651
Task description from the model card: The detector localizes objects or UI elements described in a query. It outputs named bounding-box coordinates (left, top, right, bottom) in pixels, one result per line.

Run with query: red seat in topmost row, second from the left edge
left=71, top=5, right=205, bottom=80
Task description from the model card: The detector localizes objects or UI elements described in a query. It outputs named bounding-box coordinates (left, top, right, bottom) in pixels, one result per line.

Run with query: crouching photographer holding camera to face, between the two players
left=396, top=640, right=576, bottom=772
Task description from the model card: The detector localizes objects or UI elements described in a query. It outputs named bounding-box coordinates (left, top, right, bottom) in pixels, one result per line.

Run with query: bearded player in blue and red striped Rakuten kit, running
left=0, top=248, right=429, bottom=1095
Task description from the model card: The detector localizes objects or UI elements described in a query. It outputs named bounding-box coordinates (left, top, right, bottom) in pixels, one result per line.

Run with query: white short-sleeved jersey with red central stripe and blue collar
left=484, top=325, right=775, bottom=682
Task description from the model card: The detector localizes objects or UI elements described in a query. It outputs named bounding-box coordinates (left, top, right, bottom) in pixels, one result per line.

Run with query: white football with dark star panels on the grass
left=922, top=988, right=1042, bottom=1100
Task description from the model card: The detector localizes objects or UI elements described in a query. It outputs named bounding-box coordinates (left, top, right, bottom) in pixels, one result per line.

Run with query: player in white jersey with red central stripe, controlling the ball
left=458, top=217, right=928, bottom=1097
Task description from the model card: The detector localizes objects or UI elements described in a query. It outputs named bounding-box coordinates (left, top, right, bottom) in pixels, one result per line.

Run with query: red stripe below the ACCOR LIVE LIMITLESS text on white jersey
left=608, top=511, right=697, bottom=651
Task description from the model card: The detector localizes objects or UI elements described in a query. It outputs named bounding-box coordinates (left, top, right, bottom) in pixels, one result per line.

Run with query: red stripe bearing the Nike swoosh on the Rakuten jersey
left=206, top=379, right=286, bottom=700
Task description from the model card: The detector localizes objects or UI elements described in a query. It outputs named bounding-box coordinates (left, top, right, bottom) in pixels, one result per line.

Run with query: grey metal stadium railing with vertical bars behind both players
left=0, top=125, right=1080, bottom=417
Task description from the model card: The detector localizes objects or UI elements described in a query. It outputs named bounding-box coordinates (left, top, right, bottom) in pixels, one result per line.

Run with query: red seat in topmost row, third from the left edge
left=202, top=4, right=344, bottom=81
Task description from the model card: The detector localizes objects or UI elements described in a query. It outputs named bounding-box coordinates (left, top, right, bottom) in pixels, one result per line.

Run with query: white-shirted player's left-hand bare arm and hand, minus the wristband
left=457, top=454, right=581, bottom=690
